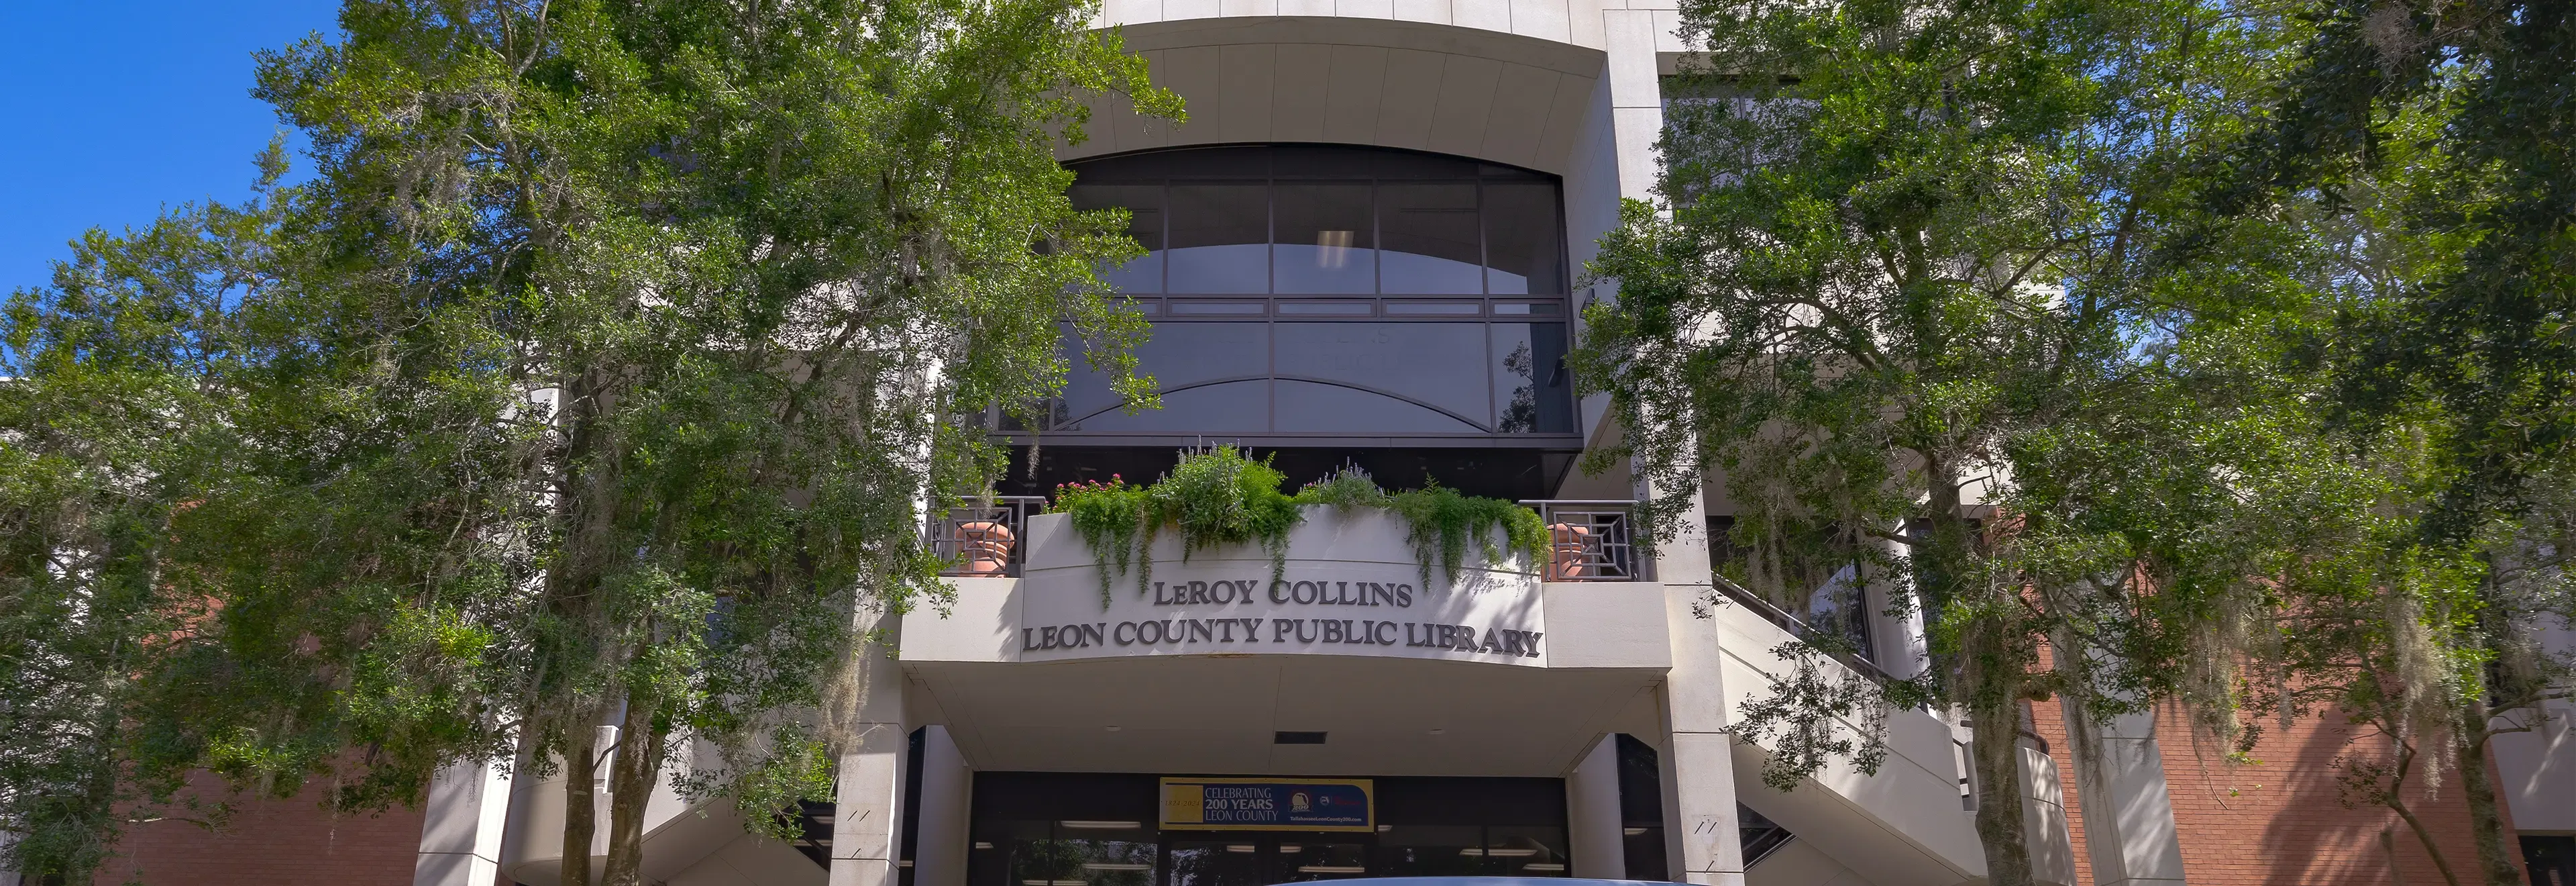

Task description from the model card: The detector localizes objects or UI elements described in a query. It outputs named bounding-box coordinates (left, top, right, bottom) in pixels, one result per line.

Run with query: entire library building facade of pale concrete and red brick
left=80, top=0, right=2576, bottom=886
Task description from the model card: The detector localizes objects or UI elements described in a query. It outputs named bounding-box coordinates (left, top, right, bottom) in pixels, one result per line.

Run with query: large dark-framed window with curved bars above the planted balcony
left=1025, top=147, right=1574, bottom=440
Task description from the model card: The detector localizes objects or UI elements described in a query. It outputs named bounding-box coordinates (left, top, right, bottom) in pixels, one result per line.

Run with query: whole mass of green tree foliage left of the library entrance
left=0, top=0, right=1180, bottom=878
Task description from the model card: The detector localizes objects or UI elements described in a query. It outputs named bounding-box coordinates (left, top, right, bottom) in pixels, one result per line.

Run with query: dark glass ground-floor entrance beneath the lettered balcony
left=966, top=773, right=1571, bottom=886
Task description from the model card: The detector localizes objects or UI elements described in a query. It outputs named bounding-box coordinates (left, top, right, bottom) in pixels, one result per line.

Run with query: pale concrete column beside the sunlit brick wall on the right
left=2058, top=695, right=2182, bottom=886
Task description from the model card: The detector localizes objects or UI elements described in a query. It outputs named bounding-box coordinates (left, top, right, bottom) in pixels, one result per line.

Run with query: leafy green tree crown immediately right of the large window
left=1574, top=0, right=2316, bottom=870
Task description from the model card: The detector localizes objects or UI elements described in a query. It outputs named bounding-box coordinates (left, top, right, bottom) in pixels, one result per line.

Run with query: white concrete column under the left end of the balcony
left=829, top=616, right=912, bottom=886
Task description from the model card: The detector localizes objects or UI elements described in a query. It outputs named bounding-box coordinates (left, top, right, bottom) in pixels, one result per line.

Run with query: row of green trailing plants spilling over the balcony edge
left=1054, top=446, right=1548, bottom=605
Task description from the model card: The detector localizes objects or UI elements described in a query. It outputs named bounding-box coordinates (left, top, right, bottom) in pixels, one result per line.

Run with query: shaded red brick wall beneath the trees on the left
left=95, top=777, right=420, bottom=886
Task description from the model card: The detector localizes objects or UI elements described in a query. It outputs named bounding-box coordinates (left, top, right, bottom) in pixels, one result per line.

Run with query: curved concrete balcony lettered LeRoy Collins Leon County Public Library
left=899, top=502, right=1672, bottom=775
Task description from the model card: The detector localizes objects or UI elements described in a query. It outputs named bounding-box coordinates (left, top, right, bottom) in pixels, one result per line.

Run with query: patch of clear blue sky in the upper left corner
left=0, top=0, right=340, bottom=293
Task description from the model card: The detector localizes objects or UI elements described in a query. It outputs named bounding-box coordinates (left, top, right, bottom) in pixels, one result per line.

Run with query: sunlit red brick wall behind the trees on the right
left=2033, top=701, right=2524, bottom=886
